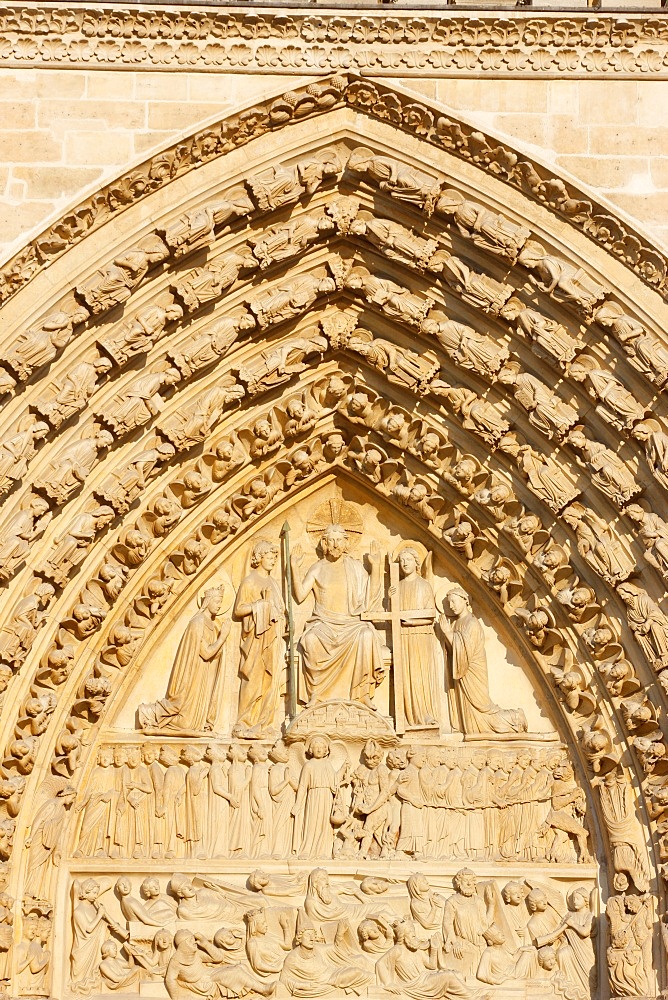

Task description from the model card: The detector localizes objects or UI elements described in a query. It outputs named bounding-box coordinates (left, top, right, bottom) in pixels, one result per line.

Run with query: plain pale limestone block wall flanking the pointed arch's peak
left=0, top=68, right=668, bottom=259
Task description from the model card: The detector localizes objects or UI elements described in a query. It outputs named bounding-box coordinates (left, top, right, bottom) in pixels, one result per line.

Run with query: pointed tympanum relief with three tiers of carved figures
left=53, top=492, right=604, bottom=1000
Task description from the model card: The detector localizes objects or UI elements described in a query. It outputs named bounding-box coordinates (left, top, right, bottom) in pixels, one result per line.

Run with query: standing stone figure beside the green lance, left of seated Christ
left=232, top=538, right=285, bottom=738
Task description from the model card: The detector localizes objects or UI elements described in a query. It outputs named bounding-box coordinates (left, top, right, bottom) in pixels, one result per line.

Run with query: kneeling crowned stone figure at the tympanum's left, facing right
left=138, top=587, right=231, bottom=736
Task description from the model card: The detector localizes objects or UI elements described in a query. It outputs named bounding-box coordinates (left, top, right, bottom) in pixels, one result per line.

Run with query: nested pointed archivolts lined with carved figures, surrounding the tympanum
left=5, top=81, right=668, bottom=996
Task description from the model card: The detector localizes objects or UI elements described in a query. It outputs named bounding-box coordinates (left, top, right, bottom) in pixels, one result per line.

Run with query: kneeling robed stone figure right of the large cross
left=444, top=587, right=527, bottom=734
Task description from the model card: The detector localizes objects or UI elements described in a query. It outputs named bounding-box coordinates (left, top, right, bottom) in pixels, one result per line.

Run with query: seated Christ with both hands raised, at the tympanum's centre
left=290, top=524, right=383, bottom=709
